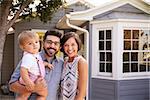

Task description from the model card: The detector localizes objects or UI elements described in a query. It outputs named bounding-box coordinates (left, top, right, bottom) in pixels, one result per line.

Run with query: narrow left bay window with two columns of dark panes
left=99, top=30, right=112, bottom=73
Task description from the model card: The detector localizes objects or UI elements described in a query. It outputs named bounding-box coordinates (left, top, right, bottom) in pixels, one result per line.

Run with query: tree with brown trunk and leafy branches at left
left=0, top=0, right=63, bottom=83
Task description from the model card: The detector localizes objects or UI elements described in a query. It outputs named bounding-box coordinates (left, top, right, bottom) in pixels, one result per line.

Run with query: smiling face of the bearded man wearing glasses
left=43, top=35, right=60, bottom=57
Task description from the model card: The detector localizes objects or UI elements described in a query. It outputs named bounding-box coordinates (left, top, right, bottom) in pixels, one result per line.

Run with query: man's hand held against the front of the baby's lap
left=34, top=76, right=47, bottom=93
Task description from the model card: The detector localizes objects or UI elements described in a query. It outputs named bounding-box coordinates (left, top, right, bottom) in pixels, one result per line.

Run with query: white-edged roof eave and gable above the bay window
left=56, top=0, right=150, bottom=29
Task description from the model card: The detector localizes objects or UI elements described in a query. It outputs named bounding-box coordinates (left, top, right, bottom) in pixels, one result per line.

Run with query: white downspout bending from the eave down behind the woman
left=66, top=14, right=89, bottom=100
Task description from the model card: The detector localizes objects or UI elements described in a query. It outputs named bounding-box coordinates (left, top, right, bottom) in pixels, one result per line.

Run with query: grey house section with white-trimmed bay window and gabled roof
left=56, top=0, right=150, bottom=100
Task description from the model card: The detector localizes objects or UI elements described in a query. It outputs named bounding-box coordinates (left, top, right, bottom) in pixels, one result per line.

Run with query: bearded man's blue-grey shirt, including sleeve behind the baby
left=9, top=51, right=63, bottom=100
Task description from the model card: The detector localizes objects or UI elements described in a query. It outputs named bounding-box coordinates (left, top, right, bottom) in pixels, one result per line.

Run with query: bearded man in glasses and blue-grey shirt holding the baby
left=9, top=31, right=63, bottom=100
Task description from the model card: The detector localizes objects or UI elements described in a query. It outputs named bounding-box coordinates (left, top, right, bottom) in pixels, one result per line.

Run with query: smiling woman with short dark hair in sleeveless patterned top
left=61, top=32, right=88, bottom=100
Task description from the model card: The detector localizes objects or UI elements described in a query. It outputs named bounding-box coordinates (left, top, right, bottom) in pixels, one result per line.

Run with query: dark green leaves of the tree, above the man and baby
left=7, top=0, right=63, bottom=22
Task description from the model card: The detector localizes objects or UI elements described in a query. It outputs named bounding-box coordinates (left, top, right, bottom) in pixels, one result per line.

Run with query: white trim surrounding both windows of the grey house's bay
left=90, top=19, right=150, bottom=80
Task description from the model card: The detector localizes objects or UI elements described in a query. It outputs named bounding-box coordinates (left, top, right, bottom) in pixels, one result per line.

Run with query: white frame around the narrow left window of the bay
left=92, top=23, right=114, bottom=79
